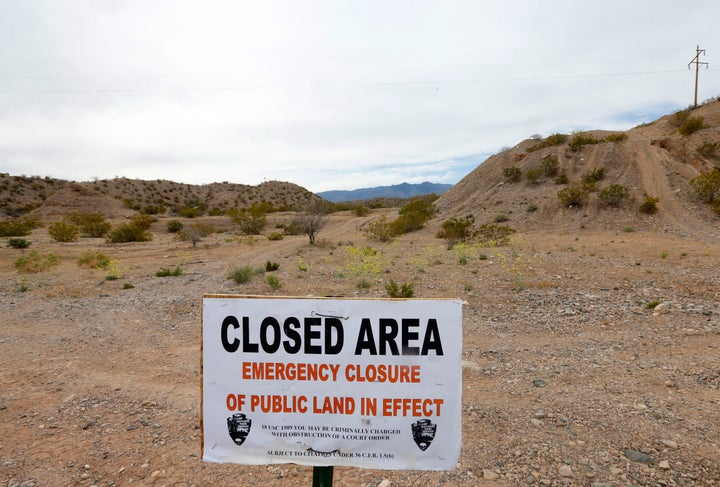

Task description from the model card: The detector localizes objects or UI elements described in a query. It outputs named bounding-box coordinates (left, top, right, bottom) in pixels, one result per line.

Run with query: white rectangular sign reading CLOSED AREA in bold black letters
left=202, top=295, right=462, bottom=470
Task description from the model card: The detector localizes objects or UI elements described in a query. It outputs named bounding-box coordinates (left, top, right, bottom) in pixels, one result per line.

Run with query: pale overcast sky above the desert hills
left=0, top=0, right=720, bottom=192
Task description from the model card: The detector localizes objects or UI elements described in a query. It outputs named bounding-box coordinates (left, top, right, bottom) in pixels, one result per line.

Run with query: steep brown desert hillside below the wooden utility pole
left=436, top=101, right=720, bottom=242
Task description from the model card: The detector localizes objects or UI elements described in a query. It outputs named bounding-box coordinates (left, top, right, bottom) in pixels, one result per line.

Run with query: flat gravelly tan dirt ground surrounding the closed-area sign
left=0, top=213, right=720, bottom=487
